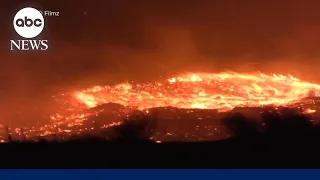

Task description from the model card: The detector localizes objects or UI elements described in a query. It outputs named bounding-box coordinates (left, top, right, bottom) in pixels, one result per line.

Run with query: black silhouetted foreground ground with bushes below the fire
left=0, top=109, right=320, bottom=168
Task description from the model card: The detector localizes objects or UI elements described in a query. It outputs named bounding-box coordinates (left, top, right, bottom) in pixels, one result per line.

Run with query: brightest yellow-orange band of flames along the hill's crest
left=72, top=73, right=320, bottom=111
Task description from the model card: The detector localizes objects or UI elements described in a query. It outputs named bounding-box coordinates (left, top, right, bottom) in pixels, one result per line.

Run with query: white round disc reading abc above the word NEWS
left=13, top=7, right=44, bottom=38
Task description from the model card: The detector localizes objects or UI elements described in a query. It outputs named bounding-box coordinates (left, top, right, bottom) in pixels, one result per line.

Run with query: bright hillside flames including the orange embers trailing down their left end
left=1, top=73, right=320, bottom=142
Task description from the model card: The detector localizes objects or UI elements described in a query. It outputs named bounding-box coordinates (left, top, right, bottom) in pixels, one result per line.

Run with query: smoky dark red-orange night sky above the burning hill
left=0, top=0, right=320, bottom=125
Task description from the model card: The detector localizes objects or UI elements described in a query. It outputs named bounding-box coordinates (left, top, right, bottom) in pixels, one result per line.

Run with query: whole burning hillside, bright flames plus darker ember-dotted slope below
left=0, top=73, right=320, bottom=142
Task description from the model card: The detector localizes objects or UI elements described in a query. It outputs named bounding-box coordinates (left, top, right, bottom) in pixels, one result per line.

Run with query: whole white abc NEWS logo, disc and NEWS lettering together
left=10, top=7, right=49, bottom=51
